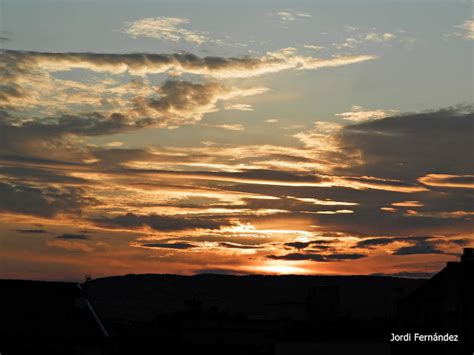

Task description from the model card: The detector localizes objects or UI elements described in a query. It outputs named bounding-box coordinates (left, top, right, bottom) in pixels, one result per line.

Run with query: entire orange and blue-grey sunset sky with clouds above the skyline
left=0, top=0, right=474, bottom=280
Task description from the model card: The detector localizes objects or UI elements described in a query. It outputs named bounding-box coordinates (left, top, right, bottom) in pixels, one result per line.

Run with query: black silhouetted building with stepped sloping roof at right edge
left=399, top=248, right=474, bottom=354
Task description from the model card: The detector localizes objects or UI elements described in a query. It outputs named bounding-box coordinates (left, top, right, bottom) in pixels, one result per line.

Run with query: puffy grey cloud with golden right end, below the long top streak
left=0, top=80, right=258, bottom=153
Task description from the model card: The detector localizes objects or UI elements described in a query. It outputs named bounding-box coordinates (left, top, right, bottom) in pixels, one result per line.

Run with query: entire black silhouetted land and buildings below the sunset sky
left=0, top=249, right=474, bottom=355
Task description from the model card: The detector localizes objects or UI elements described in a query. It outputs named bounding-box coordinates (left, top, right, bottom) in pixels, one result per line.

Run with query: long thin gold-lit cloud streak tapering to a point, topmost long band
left=0, top=47, right=376, bottom=79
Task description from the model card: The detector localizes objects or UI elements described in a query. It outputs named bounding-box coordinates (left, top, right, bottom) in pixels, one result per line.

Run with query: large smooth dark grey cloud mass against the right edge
left=339, top=106, right=474, bottom=182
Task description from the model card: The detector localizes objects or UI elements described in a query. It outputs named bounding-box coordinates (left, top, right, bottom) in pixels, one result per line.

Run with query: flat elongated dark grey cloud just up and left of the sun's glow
left=94, top=213, right=229, bottom=231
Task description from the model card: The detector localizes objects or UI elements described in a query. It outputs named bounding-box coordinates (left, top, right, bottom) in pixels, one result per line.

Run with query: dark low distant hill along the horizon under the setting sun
left=83, top=274, right=426, bottom=321
